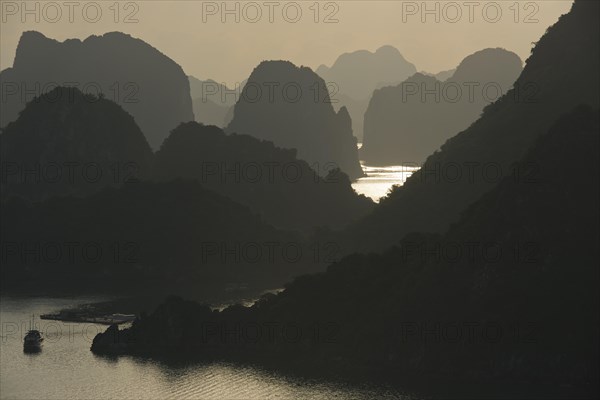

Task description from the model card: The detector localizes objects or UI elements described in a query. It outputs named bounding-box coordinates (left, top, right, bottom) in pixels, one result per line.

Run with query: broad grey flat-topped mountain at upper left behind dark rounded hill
left=0, top=31, right=194, bottom=149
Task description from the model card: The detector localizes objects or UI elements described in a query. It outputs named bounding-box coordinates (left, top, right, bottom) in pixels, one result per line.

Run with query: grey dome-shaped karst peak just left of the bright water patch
left=226, top=61, right=362, bottom=179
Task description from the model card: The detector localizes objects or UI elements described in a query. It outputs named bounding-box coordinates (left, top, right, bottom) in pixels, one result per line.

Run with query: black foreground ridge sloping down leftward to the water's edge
left=92, top=106, right=600, bottom=395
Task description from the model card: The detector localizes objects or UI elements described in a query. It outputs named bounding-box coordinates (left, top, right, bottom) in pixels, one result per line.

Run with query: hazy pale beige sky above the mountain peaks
left=0, top=0, right=572, bottom=86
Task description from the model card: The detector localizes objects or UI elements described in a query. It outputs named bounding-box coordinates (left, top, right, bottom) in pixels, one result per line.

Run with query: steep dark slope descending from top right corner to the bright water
left=350, top=1, right=600, bottom=249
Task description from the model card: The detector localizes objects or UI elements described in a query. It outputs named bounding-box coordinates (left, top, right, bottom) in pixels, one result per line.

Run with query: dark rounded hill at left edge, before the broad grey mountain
left=0, top=87, right=153, bottom=200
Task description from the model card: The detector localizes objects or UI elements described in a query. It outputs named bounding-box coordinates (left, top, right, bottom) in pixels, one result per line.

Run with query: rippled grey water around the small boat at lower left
left=0, top=297, right=409, bottom=399
